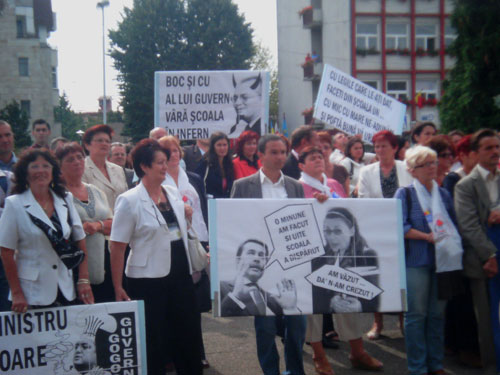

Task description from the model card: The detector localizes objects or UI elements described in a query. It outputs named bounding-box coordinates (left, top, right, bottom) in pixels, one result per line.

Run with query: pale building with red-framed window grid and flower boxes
left=277, top=0, right=456, bottom=134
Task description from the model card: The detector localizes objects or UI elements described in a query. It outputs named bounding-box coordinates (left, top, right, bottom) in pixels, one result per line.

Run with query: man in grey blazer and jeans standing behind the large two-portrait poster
left=231, top=134, right=306, bottom=375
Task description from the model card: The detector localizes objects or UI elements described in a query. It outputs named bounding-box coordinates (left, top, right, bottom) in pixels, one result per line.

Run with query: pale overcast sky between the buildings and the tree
left=49, top=0, right=277, bottom=112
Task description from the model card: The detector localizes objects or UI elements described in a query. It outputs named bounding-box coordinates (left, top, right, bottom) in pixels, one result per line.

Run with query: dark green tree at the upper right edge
left=439, top=0, right=500, bottom=133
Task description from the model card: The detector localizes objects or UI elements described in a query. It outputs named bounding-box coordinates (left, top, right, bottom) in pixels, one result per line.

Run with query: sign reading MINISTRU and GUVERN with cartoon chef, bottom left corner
left=0, top=301, right=147, bottom=375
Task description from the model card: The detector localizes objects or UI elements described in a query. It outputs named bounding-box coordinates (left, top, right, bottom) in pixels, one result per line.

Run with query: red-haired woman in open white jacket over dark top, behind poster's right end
left=358, top=130, right=412, bottom=340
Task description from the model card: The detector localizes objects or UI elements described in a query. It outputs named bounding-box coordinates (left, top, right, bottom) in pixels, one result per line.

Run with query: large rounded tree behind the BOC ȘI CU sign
left=109, top=0, right=254, bottom=141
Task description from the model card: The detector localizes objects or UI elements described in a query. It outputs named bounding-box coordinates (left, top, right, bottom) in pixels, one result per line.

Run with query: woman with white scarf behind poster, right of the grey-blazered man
left=299, top=147, right=382, bottom=375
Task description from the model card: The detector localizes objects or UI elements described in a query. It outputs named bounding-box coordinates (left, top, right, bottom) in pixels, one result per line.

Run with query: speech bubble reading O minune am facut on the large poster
left=264, top=204, right=325, bottom=270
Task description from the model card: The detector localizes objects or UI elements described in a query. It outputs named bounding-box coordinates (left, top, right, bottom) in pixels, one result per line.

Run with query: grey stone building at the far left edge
left=0, top=0, right=60, bottom=131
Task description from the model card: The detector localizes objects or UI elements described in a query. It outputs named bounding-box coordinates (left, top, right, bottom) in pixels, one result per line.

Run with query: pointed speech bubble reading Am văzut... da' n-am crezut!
left=306, top=259, right=383, bottom=300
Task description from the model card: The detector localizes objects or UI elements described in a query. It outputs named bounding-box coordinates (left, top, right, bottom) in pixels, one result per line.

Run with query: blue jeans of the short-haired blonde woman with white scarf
left=405, top=267, right=446, bottom=375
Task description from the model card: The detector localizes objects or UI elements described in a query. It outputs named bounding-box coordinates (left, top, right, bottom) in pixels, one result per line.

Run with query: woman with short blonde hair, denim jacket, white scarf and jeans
left=396, top=146, right=463, bottom=375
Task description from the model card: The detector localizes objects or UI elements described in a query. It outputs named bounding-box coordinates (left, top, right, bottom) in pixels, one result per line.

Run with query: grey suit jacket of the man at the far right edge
left=455, top=166, right=497, bottom=278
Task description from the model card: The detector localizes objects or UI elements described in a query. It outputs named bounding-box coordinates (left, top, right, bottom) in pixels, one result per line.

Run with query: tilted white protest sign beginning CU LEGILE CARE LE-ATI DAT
left=313, top=64, right=406, bottom=143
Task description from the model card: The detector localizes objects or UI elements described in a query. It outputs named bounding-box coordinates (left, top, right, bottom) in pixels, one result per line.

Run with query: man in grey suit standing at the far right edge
left=455, top=129, right=500, bottom=367
